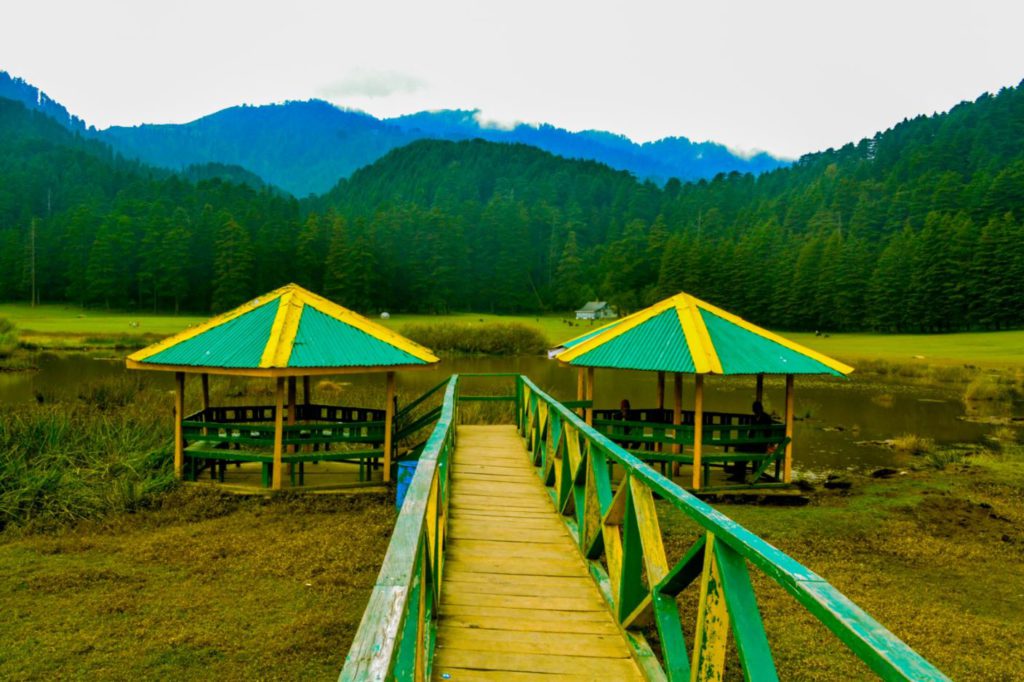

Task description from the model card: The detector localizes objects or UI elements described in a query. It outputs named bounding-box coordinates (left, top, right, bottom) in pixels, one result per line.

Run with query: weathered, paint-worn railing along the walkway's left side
left=339, top=375, right=459, bottom=681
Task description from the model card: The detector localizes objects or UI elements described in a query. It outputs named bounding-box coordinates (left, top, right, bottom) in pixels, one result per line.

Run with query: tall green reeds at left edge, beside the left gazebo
left=0, top=377, right=174, bottom=529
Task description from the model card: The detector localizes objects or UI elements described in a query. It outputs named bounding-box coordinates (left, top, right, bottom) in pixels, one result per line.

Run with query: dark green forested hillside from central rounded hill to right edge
left=309, top=79, right=1024, bottom=331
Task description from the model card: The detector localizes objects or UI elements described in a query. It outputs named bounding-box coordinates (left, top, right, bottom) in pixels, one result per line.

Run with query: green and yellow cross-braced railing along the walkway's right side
left=517, top=377, right=947, bottom=680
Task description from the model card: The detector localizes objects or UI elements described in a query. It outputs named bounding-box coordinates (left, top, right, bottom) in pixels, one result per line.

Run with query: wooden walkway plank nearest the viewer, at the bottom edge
left=434, top=647, right=643, bottom=680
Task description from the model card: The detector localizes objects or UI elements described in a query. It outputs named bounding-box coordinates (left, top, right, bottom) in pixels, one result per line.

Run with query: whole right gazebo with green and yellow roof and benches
left=550, top=293, right=853, bottom=489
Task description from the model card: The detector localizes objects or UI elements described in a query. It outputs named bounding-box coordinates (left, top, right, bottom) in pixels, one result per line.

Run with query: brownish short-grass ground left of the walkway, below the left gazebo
left=0, top=488, right=394, bottom=680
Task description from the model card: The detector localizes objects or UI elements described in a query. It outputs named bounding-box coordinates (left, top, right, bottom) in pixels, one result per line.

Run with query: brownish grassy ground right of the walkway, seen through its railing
left=662, top=434, right=1024, bottom=681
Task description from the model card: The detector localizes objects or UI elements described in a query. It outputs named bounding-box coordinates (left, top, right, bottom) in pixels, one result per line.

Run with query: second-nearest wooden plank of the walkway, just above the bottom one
left=437, top=626, right=630, bottom=658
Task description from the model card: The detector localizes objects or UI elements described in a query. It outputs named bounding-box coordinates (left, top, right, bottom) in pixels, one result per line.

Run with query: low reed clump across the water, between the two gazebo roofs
left=401, top=322, right=548, bottom=355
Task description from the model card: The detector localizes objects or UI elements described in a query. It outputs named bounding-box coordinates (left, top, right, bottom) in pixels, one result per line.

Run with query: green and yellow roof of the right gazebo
left=551, top=293, right=853, bottom=376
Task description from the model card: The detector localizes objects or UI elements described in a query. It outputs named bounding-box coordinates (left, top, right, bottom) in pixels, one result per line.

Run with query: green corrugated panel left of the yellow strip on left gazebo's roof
left=141, top=298, right=281, bottom=369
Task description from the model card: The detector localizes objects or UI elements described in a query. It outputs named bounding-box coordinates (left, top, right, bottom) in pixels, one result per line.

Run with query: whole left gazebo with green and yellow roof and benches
left=127, top=284, right=439, bottom=491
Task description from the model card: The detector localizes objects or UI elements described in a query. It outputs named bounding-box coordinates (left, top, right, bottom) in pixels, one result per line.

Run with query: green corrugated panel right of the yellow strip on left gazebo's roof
left=288, top=305, right=427, bottom=368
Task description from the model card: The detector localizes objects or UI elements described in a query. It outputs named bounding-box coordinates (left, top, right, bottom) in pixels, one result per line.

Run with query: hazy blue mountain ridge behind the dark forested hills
left=0, top=72, right=790, bottom=197
